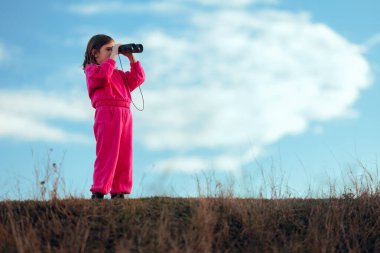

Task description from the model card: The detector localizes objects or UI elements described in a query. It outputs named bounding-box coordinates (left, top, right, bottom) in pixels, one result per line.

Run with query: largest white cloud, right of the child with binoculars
left=136, top=10, right=372, bottom=171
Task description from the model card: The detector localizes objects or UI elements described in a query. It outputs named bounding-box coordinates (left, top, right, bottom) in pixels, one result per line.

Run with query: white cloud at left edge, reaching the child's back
left=0, top=90, right=92, bottom=143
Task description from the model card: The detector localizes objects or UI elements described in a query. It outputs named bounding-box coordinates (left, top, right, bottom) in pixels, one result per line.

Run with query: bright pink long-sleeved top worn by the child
left=84, top=58, right=145, bottom=108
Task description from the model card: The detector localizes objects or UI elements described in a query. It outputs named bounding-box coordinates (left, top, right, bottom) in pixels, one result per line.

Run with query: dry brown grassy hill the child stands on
left=0, top=196, right=380, bottom=252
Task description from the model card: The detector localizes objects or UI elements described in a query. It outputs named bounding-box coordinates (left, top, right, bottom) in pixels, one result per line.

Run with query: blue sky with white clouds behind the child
left=0, top=0, right=380, bottom=199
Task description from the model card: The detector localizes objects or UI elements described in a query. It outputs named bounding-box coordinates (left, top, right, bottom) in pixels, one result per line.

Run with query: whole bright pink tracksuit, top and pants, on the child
left=84, top=58, right=145, bottom=194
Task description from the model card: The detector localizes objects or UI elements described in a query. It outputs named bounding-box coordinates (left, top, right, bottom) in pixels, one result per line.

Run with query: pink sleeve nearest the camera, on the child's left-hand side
left=85, top=58, right=116, bottom=89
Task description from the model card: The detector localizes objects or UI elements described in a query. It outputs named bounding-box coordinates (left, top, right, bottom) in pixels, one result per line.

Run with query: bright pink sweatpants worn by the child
left=91, top=106, right=132, bottom=194
